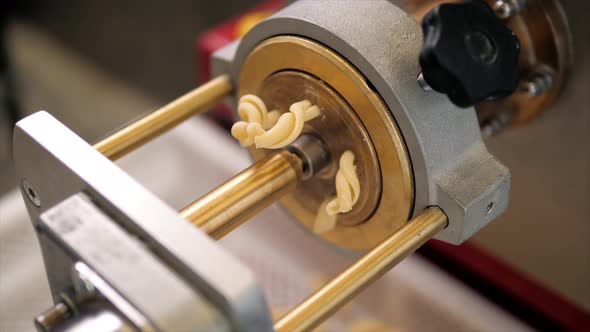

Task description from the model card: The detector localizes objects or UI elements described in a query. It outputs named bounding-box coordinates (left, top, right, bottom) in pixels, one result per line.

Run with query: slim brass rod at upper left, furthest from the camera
left=94, top=75, right=232, bottom=160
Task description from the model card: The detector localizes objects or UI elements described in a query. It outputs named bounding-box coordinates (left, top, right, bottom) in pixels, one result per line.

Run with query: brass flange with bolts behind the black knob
left=404, top=0, right=573, bottom=127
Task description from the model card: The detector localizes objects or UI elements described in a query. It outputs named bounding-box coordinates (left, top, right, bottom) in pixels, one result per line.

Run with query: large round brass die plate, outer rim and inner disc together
left=238, top=36, right=414, bottom=250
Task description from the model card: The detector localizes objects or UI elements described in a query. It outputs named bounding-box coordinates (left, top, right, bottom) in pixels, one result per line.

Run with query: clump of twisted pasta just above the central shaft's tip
left=231, top=95, right=320, bottom=149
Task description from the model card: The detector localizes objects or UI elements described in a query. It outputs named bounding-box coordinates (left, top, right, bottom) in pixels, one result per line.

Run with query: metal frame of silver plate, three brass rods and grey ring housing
left=14, top=0, right=524, bottom=332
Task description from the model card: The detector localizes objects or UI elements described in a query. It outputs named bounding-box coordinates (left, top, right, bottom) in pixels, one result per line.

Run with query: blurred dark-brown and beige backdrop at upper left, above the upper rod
left=0, top=0, right=258, bottom=193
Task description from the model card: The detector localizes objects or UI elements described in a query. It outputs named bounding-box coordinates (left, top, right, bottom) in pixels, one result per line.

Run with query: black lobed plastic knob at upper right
left=420, top=0, right=520, bottom=107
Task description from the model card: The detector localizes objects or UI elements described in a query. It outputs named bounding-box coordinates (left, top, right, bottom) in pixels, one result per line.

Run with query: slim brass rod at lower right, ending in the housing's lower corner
left=274, top=207, right=448, bottom=332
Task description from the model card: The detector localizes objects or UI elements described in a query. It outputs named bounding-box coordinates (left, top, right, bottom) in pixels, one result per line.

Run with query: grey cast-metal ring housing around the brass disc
left=216, top=0, right=510, bottom=243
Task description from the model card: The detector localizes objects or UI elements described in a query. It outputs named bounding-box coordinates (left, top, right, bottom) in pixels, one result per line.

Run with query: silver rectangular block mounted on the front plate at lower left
left=37, top=194, right=229, bottom=332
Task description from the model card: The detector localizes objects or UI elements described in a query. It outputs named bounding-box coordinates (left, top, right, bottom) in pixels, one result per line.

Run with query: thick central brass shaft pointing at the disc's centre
left=180, top=151, right=303, bottom=239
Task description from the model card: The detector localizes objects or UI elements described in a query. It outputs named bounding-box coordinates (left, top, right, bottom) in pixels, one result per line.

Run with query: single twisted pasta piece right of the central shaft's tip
left=326, top=151, right=361, bottom=216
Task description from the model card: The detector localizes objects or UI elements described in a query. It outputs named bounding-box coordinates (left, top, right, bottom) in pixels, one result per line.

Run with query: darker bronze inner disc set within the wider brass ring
left=252, top=70, right=381, bottom=226
